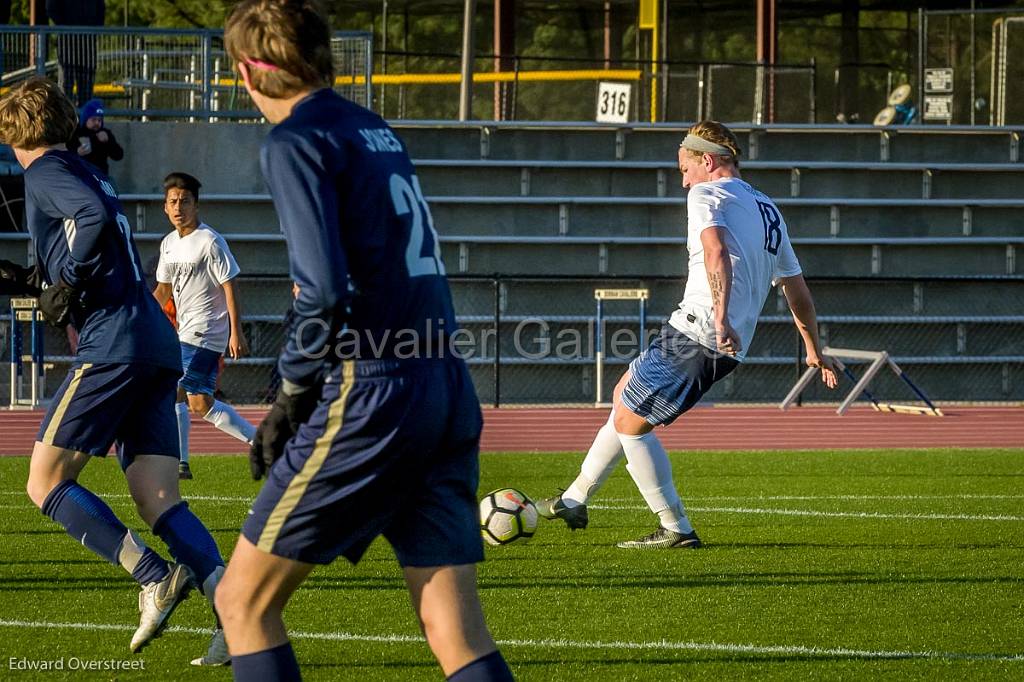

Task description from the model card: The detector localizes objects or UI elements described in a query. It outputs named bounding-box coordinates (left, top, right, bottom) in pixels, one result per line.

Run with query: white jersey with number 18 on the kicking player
left=669, top=178, right=801, bottom=360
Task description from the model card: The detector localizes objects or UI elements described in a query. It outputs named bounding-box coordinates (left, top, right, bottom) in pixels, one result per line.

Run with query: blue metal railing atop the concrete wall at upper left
left=0, top=26, right=373, bottom=120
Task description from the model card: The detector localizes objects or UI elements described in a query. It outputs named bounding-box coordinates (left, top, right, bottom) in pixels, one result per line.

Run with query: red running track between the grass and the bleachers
left=0, top=407, right=1024, bottom=455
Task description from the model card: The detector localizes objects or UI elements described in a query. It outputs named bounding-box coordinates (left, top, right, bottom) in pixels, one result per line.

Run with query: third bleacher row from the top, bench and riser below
left=122, top=191, right=1024, bottom=238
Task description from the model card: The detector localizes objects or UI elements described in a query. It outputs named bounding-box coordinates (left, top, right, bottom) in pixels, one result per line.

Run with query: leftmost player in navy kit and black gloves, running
left=0, top=78, right=226, bottom=664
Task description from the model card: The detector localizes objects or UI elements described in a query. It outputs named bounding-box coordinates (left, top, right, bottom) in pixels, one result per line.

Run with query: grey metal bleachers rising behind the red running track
left=6, top=122, right=1024, bottom=402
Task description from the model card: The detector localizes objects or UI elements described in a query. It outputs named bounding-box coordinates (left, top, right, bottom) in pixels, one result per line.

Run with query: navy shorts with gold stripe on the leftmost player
left=37, top=363, right=178, bottom=469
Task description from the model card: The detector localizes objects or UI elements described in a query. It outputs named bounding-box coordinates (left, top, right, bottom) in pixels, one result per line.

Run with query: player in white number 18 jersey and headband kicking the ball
left=537, top=121, right=837, bottom=549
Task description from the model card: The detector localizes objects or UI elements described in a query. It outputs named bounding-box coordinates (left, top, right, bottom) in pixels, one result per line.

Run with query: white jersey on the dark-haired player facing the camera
left=157, top=223, right=239, bottom=353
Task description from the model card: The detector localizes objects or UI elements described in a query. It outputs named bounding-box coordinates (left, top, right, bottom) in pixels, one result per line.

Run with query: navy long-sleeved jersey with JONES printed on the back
left=260, top=89, right=456, bottom=385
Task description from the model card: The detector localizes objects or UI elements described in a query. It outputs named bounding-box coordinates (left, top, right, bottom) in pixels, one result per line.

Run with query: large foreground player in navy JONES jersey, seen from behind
left=217, top=0, right=511, bottom=682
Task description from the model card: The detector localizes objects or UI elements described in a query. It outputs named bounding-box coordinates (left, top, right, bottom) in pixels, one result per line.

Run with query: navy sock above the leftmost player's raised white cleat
left=42, top=480, right=169, bottom=585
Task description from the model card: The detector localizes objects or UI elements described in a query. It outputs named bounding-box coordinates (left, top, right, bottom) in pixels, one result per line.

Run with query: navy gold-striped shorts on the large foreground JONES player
left=242, top=359, right=483, bottom=566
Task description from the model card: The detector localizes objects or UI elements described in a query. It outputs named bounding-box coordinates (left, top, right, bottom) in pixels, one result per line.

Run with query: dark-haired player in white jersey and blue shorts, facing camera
left=153, top=173, right=256, bottom=478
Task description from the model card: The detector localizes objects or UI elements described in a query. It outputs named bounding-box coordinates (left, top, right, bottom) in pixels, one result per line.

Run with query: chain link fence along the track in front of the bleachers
left=8, top=275, right=1024, bottom=406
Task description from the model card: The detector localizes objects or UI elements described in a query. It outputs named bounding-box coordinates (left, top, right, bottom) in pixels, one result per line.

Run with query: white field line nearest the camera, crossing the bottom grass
left=0, top=620, right=1024, bottom=663
